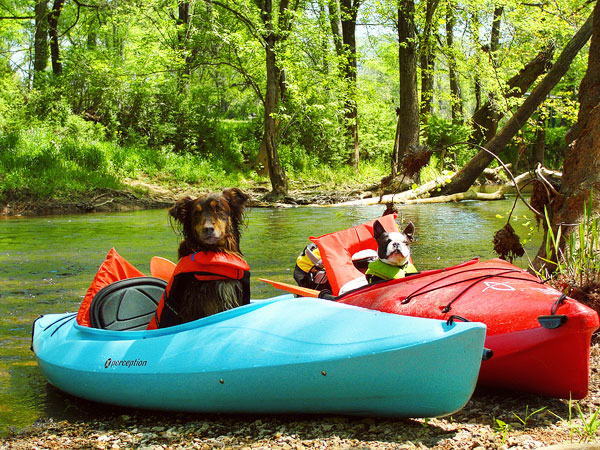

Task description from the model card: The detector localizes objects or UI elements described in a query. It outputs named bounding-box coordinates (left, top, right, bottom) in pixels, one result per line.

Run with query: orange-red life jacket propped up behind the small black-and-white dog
left=310, top=214, right=399, bottom=295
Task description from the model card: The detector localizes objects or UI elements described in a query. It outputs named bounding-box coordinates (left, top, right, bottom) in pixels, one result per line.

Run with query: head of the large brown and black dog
left=169, top=188, right=249, bottom=257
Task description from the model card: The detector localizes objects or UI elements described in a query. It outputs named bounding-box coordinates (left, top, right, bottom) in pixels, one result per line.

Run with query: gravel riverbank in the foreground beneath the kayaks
left=0, top=345, right=600, bottom=450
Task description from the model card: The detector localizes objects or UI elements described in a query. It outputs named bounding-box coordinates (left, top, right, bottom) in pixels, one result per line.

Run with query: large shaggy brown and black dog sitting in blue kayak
left=159, top=188, right=250, bottom=328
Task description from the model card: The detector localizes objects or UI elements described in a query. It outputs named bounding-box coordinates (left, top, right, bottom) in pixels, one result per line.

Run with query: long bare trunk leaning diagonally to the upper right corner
left=440, top=16, right=593, bottom=195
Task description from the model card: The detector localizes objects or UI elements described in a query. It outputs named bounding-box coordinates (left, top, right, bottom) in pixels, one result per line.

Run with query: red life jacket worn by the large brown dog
left=148, top=252, right=250, bottom=330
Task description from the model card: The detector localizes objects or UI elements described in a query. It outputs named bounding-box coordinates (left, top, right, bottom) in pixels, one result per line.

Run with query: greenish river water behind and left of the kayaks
left=0, top=199, right=541, bottom=434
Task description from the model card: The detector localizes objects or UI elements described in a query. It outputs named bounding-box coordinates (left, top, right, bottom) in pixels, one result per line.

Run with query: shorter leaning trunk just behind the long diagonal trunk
left=469, top=44, right=554, bottom=144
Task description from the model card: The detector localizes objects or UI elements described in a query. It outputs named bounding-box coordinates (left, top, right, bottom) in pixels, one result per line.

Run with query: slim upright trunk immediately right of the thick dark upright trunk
left=420, top=0, right=440, bottom=123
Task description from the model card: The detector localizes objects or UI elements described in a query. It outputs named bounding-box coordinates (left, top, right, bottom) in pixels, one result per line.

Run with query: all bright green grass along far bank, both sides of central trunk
left=0, top=118, right=385, bottom=204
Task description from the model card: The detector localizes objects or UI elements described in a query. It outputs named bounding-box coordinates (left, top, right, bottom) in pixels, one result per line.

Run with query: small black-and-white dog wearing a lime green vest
left=366, top=221, right=417, bottom=283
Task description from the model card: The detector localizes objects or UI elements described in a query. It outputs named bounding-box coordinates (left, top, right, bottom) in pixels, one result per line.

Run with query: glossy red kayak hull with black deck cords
left=339, top=259, right=599, bottom=399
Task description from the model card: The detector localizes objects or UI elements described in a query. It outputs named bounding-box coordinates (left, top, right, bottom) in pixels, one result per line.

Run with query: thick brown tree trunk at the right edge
left=534, top=2, right=600, bottom=268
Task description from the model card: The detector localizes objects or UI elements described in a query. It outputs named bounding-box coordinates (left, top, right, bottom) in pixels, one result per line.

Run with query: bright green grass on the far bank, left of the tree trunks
left=0, top=122, right=250, bottom=199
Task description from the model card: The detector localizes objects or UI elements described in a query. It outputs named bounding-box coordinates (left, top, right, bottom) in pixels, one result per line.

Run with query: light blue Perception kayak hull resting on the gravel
left=32, top=295, right=485, bottom=417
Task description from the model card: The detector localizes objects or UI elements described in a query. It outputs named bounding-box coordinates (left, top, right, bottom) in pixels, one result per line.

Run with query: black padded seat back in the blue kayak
left=90, top=277, right=167, bottom=331
